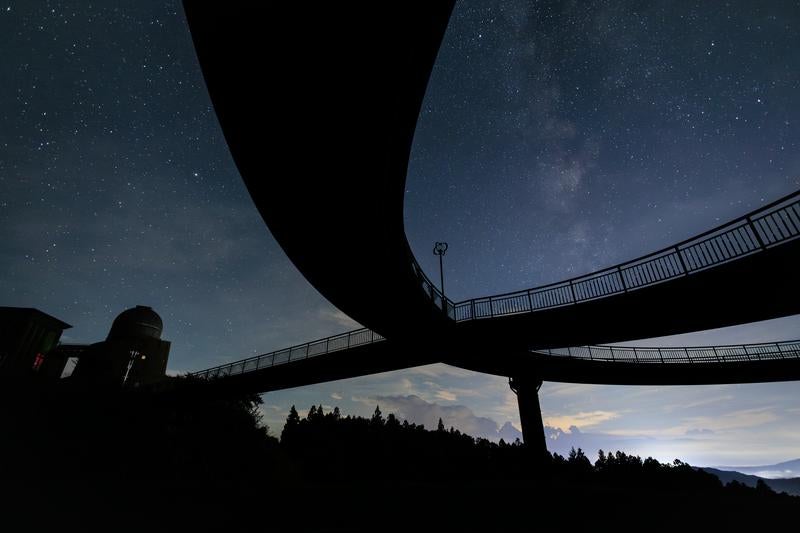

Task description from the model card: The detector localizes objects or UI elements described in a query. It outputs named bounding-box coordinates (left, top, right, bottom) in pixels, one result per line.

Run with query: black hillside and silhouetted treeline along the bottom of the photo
left=0, top=376, right=800, bottom=532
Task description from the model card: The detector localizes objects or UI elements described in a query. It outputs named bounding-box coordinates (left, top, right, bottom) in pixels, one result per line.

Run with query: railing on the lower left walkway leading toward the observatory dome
left=189, top=328, right=384, bottom=379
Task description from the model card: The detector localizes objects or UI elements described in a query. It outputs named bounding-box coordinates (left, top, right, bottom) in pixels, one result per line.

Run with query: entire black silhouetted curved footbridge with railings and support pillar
left=184, top=2, right=800, bottom=451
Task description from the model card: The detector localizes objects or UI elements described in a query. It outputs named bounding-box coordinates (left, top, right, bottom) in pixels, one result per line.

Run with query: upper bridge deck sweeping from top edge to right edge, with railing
left=185, top=2, right=800, bottom=354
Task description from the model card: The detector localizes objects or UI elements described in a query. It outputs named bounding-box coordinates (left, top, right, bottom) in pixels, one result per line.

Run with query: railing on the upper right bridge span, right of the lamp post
left=450, top=191, right=800, bottom=322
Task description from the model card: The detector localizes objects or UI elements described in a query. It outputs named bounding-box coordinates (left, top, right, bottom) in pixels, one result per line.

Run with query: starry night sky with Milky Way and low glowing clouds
left=0, top=1, right=800, bottom=465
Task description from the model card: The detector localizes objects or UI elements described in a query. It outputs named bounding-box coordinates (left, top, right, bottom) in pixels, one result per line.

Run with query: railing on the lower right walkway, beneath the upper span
left=534, top=341, right=800, bottom=364
